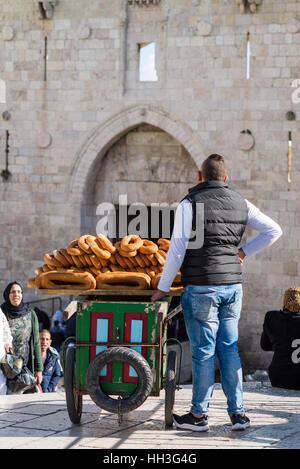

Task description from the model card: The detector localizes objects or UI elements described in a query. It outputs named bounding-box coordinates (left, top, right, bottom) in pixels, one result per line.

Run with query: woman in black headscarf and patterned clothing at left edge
left=1, top=282, right=43, bottom=393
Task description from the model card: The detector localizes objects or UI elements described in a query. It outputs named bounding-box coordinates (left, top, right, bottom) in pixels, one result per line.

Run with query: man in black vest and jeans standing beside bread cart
left=151, top=154, right=282, bottom=431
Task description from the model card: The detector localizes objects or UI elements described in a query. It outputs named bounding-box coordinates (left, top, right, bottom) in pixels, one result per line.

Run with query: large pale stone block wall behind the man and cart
left=0, top=0, right=300, bottom=369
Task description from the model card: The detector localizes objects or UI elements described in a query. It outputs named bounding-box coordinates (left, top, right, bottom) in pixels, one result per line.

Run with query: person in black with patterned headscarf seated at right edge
left=260, top=287, right=300, bottom=390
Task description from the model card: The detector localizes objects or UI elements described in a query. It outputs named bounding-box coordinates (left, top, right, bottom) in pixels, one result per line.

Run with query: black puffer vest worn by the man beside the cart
left=181, top=181, right=248, bottom=286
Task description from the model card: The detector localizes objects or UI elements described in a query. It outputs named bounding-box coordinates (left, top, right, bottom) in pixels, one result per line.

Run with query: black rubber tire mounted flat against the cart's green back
left=85, top=347, right=153, bottom=414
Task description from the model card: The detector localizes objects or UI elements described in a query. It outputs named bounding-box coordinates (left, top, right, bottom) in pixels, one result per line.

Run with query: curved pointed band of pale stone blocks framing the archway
left=68, top=105, right=208, bottom=204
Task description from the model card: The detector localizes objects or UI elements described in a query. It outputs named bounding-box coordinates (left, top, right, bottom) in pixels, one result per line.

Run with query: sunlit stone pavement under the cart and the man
left=0, top=382, right=300, bottom=453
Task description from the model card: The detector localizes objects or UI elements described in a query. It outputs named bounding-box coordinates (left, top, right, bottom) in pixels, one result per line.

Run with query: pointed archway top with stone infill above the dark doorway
left=69, top=105, right=209, bottom=238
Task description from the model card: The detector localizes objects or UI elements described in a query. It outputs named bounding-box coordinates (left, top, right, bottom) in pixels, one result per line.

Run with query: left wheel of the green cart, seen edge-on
left=64, top=346, right=82, bottom=423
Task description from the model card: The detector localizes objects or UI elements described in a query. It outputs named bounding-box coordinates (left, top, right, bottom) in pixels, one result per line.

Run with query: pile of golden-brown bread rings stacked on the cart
left=27, top=233, right=182, bottom=291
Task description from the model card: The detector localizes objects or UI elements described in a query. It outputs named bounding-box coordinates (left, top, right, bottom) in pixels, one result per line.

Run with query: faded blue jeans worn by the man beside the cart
left=181, top=284, right=244, bottom=415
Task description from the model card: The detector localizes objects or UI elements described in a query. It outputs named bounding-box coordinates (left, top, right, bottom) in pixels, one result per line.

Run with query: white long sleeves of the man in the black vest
left=158, top=199, right=282, bottom=292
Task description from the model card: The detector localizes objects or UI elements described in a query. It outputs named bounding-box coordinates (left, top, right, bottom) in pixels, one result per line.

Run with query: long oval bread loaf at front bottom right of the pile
left=96, top=272, right=151, bottom=290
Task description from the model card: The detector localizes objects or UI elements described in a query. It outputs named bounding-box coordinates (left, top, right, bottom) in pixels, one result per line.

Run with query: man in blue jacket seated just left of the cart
left=40, top=329, right=62, bottom=392
